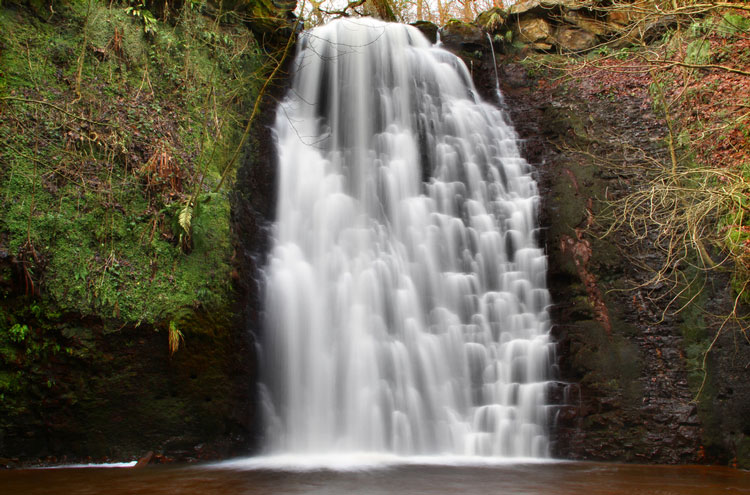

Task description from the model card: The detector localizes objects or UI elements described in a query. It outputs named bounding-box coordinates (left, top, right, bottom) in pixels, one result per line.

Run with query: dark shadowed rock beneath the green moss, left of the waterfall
left=0, top=312, right=253, bottom=465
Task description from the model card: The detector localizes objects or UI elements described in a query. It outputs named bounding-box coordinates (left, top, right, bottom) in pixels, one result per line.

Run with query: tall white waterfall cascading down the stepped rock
left=262, top=19, right=553, bottom=457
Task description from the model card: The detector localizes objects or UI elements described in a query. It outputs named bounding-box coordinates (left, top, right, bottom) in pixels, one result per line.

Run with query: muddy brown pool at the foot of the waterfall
left=0, top=463, right=750, bottom=495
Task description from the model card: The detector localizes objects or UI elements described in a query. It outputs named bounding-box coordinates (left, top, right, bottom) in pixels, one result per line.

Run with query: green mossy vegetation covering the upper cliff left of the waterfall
left=0, top=1, right=264, bottom=326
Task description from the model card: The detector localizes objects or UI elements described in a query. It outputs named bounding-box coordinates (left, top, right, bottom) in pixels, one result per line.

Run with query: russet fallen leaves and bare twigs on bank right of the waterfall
left=526, top=4, right=750, bottom=324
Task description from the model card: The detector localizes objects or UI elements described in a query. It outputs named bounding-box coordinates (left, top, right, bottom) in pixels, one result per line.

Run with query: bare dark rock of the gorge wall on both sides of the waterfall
left=0, top=2, right=750, bottom=468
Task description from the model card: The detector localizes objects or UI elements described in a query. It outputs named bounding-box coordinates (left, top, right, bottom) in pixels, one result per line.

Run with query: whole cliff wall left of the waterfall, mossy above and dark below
left=0, top=0, right=291, bottom=466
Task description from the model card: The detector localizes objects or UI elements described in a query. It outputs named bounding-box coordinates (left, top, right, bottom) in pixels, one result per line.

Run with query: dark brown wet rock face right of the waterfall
left=462, top=52, right=750, bottom=466
